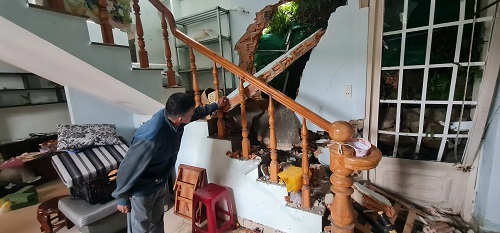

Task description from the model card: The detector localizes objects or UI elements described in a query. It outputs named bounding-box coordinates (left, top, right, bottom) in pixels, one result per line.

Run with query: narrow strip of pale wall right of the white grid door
left=473, top=74, right=500, bottom=232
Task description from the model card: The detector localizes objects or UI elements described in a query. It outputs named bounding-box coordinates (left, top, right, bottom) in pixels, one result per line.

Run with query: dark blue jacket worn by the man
left=112, top=103, right=218, bottom=205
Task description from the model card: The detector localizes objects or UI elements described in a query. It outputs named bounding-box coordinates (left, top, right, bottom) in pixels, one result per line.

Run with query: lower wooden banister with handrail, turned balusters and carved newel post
left=149, top=0, right=382, bottom=232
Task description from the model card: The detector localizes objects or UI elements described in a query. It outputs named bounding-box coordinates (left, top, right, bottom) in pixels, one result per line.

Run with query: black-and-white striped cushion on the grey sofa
left=52, top=144, right=128, bottom=188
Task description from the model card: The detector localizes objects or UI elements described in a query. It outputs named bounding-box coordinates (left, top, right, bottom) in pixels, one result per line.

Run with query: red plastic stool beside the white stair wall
left=192, top=183, right=236, bottom=233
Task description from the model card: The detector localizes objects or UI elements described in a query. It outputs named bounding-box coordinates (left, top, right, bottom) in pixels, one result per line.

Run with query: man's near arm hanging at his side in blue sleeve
left=112, top=140, right=154, bottom=206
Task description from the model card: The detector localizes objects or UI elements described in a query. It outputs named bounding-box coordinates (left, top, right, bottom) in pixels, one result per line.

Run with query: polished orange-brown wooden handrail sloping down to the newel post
left=149, top=0, right=333, bottom=133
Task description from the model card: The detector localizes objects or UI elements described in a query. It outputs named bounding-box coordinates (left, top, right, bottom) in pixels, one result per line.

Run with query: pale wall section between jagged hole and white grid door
left=296, top=0, right=368, bottom=131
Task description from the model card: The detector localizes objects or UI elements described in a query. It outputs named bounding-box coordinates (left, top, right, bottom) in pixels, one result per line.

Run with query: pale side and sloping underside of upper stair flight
left=0, top=1, right=163, bottom=115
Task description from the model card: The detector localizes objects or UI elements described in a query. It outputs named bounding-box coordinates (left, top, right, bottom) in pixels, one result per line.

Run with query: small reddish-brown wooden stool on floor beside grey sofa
left=36, top=196, right=73, bottom=233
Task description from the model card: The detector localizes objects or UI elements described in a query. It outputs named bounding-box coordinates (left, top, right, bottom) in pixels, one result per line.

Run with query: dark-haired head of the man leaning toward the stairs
left=165, top=93, right=195, bottom=125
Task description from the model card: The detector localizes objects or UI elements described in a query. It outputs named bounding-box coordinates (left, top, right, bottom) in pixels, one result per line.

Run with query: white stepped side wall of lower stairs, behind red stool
left=176, top=121, right=322, bottom=233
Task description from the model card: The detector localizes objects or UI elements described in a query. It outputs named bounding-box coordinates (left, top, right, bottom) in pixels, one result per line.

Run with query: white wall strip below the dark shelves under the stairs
left=0, top=103, right=70, bottom=141
